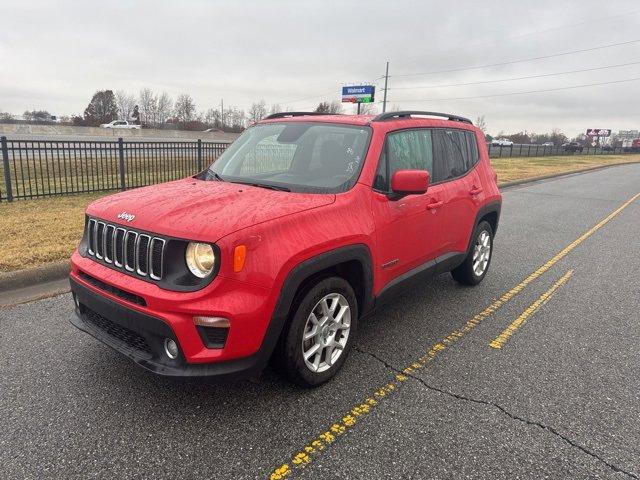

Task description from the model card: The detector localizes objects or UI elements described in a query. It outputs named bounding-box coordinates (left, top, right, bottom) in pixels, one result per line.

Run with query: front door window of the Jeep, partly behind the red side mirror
left=374, top=129, right=433, bottom=191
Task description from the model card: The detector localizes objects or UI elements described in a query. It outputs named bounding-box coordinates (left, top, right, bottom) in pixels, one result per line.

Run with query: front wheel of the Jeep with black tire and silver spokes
left=280, top=277, right=358, bottom=387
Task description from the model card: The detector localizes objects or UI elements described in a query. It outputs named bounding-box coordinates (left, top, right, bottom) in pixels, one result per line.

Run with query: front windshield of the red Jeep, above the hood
left=203, top=122, right=371, bottom=193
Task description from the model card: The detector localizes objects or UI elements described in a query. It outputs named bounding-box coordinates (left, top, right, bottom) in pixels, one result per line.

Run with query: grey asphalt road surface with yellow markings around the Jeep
left=0, top=165, right=640, bottom=479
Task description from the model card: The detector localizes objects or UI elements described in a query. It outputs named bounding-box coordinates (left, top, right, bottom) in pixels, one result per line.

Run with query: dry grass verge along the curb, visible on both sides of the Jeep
left=0, top=155, right=640, bottom=272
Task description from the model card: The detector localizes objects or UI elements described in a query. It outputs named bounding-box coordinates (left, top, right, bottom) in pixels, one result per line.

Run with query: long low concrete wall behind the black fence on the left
left=0, top=123, right=238, bottom=142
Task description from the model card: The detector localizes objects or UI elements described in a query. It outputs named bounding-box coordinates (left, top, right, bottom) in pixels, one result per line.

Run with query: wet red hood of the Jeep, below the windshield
left=87, top=178, right=335, bottom=242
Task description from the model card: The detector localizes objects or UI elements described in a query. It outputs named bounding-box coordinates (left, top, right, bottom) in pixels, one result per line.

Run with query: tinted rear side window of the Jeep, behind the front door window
left=433, top=129, right=478, bottom=182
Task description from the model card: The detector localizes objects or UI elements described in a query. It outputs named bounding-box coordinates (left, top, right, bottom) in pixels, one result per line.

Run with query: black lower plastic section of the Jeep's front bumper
left=70, top=278, right=272, bottom=379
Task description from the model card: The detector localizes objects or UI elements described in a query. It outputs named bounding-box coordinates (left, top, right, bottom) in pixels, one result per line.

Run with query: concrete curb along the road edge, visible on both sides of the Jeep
left=0, top=162, right=640, bottom=292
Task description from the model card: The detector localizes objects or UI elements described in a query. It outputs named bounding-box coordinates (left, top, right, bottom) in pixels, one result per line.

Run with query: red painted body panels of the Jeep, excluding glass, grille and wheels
left=71, top=115, right=501, bottom=376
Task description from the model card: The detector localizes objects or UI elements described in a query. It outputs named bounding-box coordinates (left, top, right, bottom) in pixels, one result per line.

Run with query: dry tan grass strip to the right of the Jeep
left=491, top=154, right=640, bottom=182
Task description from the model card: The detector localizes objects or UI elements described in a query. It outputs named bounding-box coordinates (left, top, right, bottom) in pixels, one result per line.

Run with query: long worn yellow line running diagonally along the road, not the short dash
left=268, top=193, right=640, bottom=480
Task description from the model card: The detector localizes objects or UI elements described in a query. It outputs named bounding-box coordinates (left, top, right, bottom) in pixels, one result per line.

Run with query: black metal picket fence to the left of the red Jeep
left=0, top=137, right=229, bottom=202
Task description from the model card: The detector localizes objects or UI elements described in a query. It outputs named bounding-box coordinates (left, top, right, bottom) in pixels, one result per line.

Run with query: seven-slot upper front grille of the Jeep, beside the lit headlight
left=87, top=218, right=166, bottom=280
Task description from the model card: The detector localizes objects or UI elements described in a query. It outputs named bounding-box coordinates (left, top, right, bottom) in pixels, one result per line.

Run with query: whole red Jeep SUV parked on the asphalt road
left=70, top=112, right=501, bottom=386
